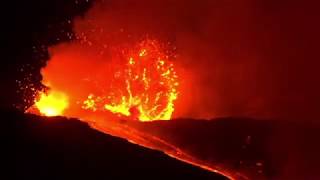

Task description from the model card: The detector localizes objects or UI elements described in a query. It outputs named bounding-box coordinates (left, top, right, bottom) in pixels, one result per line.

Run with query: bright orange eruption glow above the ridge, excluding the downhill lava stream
left=27, top=39, right=179, bottom=121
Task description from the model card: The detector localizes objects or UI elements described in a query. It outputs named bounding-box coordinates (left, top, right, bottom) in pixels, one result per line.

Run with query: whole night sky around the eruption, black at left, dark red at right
left=0, top=0, right=320, bottom=121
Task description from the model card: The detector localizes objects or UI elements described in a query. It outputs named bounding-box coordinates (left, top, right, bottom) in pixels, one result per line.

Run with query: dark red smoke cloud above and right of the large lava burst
left=49, top=0, right=320, bottom=120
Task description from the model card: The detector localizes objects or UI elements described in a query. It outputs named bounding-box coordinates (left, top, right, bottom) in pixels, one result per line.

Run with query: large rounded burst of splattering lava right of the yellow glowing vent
left=82, top=40, right=179, bottom=121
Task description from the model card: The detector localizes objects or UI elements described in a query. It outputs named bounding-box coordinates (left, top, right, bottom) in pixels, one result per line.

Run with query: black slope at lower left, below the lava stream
left=0, top=111, right=226, bottom=180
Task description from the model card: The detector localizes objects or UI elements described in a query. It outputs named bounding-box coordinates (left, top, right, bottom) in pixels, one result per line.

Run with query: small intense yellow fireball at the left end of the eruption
left=35, top=91, right=69, bottom=116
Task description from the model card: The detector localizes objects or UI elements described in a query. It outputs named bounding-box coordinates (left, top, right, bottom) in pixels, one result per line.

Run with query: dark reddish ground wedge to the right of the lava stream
left=128, top=118, right=320, bottom=180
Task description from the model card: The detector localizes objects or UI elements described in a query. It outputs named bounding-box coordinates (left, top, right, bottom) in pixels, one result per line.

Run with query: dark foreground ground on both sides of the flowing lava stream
left=0, top=107, right=320, bottom=180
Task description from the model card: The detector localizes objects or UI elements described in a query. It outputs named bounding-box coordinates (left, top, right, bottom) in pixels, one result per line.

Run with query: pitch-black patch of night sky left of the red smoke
left=0, top=0, right=91, bottom=108
